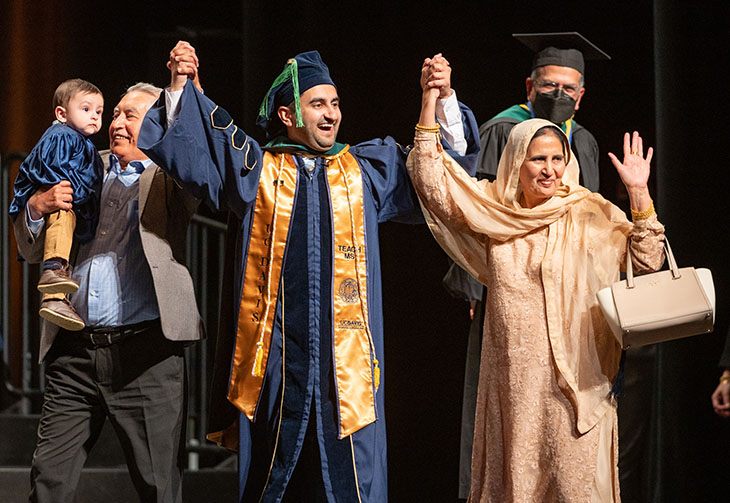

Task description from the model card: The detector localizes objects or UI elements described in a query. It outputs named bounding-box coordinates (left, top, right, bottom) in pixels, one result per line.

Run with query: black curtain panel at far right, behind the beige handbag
left=653, top=0, right=730, bottom=503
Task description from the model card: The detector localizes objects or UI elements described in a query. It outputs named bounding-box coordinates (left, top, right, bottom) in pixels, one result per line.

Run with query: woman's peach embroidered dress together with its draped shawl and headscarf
left=408, top=120, right=664, bottom=503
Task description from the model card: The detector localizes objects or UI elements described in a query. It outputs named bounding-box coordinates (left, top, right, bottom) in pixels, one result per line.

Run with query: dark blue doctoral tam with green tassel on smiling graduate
left=256, top=51, right=337, bottom=138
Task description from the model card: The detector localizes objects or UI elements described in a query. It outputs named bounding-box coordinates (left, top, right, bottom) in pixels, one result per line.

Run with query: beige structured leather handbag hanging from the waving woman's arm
left=597, top=241, right=715, bottom=349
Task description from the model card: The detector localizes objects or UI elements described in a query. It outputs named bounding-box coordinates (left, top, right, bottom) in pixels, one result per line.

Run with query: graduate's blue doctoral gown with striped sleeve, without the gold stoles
left=139, top=82, right=479, bottom=503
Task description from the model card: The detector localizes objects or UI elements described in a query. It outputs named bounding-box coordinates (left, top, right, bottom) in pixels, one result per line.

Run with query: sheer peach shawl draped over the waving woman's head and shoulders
left=407, top=119, right=632, bottom=433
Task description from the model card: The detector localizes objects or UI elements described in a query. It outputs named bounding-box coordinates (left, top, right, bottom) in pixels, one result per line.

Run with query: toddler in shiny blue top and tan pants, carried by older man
left=10, top=79, right=104, bottom=330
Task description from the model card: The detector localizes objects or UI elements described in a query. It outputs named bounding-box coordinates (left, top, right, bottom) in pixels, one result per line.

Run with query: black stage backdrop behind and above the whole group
left=0, top=0, right=730, bottom=502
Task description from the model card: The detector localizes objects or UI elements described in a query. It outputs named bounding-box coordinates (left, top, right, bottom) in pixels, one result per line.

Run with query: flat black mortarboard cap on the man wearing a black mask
left=512, top=31, right=611, bottom=75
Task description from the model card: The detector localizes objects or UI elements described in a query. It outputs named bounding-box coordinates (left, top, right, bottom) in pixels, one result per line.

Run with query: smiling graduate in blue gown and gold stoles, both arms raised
left=140, top=42, right=479, bottom=503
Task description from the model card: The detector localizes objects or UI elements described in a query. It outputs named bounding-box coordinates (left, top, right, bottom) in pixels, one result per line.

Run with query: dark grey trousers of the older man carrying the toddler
left=30, top=324, right=186, bottom=503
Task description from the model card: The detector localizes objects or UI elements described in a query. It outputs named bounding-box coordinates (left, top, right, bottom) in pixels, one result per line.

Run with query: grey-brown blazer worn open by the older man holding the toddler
left=14, top=150, right=204, bottom=362
